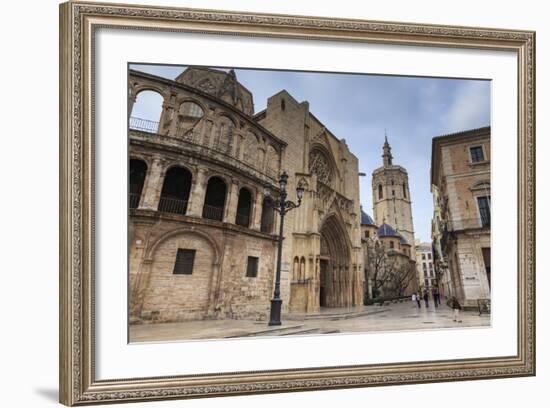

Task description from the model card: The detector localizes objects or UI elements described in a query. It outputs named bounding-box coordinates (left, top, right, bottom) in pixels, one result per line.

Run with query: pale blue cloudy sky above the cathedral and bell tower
left=131, top=65, right=491, bottom=242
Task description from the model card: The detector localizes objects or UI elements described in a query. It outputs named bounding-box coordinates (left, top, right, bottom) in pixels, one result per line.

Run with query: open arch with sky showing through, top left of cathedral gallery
left=130, top=91, right=164, bottom=133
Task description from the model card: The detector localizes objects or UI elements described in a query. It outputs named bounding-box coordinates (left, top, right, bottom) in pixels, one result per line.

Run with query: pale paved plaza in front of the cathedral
left=130, top=301, right=491, bottom=342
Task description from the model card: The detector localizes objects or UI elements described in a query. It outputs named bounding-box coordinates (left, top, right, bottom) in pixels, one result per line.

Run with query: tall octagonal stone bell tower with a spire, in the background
left=372, top=134, right=415, bottom=260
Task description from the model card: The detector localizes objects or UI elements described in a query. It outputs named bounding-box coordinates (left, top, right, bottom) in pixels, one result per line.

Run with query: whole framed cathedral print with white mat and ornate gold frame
left=60, top=2, right=535, bottom=405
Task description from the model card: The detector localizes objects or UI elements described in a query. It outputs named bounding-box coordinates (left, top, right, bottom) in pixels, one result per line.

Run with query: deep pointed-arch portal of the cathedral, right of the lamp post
left=319, top=215, right=353, bottom=307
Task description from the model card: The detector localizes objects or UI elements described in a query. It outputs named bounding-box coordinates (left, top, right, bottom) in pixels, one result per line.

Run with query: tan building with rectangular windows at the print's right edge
left=431, top=127, right=491, bottom=307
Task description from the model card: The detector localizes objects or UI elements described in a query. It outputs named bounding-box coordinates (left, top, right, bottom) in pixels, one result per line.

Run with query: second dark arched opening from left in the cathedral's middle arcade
left=159, top=167, right=192, bottom=214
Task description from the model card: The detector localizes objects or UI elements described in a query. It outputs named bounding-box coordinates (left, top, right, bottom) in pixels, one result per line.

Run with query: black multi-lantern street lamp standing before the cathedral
left=264, top=171, right=304, bottom=326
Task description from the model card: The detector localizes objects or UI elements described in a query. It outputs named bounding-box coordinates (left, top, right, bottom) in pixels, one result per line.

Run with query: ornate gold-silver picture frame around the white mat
left=59, top=2, right=535, bottom=406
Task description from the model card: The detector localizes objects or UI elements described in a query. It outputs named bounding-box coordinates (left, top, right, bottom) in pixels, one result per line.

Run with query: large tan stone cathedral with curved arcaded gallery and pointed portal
left=128, top=67, right=366, bottom=323
